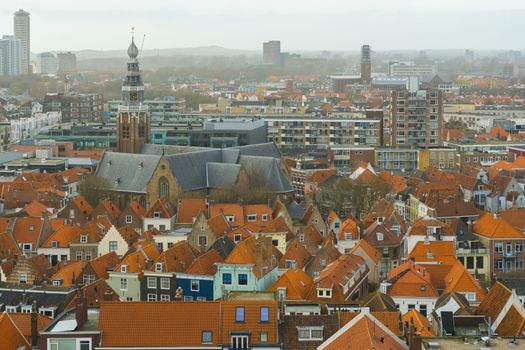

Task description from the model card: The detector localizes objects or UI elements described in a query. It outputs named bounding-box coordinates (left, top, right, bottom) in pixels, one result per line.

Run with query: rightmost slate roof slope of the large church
left=239, top=155, right=295, bottom=193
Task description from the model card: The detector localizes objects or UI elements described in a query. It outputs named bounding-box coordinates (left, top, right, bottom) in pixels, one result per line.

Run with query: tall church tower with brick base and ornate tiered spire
left=117, top=33, right=151, bottom=153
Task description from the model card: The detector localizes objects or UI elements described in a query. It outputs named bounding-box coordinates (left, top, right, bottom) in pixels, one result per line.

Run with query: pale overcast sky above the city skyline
left=0, top=0, right=525, bottom=52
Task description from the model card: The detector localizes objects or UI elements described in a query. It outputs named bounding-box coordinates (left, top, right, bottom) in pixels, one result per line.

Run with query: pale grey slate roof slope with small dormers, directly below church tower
left=96, top=152, right=160, bottom=193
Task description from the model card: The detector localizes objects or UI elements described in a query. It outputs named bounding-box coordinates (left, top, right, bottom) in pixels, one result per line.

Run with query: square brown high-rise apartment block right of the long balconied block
left=390, top=87, right=443, bottom=147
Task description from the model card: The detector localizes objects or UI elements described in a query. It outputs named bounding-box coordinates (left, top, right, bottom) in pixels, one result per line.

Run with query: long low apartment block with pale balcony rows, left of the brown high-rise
left=264, top=113, right=382, bottom=150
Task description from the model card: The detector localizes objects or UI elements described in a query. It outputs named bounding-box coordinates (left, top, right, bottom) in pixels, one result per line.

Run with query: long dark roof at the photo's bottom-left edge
left=0, top=288, right=75, bottom=316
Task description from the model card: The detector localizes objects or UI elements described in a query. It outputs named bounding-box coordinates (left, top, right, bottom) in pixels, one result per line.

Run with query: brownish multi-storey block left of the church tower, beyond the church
left=44, top=93, right=104, bottom=123
